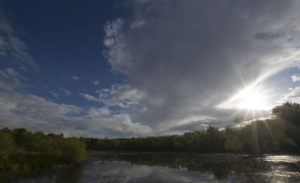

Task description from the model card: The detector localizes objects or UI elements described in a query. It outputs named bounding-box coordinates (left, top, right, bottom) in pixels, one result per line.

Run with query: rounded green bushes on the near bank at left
left=0, top=128, right=86, bottom=180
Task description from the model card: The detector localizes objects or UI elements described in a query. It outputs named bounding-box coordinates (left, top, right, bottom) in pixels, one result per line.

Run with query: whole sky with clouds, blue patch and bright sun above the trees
left=0, top=0, right=300, bottom=138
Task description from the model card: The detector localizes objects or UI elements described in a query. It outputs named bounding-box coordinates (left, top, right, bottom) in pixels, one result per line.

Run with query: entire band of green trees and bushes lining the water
left=0, top=103, right=300, bottom=179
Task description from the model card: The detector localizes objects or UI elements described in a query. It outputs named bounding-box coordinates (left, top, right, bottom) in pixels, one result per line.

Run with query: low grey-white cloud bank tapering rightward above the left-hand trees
left=0, top=68, right=151, bottom=137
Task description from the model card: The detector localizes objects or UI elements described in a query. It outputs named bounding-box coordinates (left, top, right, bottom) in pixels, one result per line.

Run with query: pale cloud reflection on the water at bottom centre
left=81, top=162, right=220, bottom=183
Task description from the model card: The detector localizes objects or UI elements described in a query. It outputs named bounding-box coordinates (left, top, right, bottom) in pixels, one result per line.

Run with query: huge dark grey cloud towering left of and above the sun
left=103, top=0, right=300, bottom=130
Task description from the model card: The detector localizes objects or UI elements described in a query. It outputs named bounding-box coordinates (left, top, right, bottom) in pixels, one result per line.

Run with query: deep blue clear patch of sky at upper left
left=0, top=1, right=122, bottom=104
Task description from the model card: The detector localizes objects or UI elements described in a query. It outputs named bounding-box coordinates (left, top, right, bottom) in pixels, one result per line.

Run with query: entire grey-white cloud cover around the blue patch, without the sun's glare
left=0, top=0, right=300, bottom=137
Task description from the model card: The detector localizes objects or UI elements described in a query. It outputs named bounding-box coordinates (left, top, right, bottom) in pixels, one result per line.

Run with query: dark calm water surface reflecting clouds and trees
left=10, top=152, right=300, bottom=183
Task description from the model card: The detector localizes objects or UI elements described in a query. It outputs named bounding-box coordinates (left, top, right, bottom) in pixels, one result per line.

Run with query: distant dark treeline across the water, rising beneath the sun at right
left=81, top=103, right=300, bottom=155
